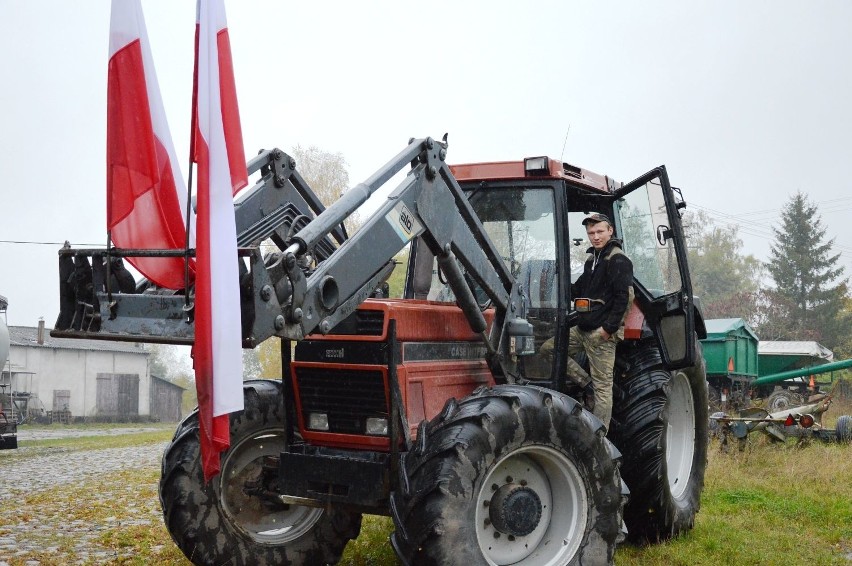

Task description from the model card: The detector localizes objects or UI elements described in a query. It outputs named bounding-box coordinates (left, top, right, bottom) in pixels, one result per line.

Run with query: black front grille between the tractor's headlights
left=296, top=367, right=388, bottom=434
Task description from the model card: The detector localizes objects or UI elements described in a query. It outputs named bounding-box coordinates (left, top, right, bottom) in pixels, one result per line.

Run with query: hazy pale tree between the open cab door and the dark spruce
left=684, top=211, right=762, bottom=323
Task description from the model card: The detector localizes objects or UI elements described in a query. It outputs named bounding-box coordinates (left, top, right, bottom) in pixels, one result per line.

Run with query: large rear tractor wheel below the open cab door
left=609, top=340, right=709, bottom=543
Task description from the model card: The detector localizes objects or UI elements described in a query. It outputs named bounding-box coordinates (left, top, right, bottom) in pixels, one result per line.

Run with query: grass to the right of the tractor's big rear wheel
left=616, top=435, right=852, bottom=565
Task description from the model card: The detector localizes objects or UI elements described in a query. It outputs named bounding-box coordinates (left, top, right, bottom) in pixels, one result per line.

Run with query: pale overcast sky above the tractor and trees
left=0, top=0, right=852, bottom=326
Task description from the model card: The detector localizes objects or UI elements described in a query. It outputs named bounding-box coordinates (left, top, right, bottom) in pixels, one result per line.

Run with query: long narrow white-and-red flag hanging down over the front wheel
left=191, top=0, right=248, bottom=481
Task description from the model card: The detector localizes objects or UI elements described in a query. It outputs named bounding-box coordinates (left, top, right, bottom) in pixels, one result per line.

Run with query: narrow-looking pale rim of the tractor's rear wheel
left=666, top=371, right=695, bottom=499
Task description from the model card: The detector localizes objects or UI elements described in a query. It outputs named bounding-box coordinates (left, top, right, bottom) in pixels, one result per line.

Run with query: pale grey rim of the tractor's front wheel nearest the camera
left=475, top=446, right=589, bottom=566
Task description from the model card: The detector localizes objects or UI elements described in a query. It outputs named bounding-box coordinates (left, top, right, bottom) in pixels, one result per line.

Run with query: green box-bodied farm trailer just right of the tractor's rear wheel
left=701, top=318, right=759, bottom=410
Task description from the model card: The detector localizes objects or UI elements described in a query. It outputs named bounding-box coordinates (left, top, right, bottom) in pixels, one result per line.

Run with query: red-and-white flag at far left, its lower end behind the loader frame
left=107, top=0, right=194, bottom=289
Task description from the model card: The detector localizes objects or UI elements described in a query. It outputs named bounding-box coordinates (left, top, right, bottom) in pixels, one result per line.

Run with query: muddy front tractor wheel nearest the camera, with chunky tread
left=391, top=386, right=626, bottom=566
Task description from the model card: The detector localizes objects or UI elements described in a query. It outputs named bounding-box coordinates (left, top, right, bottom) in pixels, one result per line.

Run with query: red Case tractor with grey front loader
left=52, top=138, right=708, bottom=565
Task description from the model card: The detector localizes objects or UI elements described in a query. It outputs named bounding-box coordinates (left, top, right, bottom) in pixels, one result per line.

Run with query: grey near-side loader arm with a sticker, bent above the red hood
left=270, top=139, right=514, bottom=340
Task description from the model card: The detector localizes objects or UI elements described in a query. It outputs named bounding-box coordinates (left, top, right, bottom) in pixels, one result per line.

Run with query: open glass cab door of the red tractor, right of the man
left=614, top=166, right=696, bottom=369
